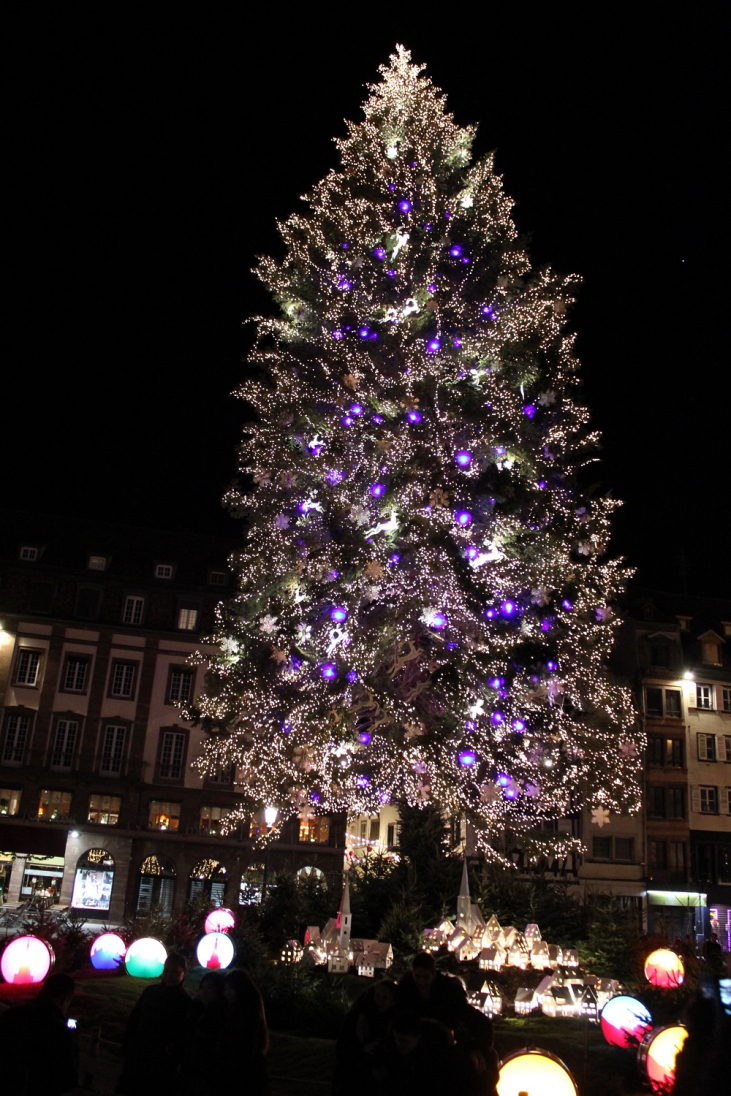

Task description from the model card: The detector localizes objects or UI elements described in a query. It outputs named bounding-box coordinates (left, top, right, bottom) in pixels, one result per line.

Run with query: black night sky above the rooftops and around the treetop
left=7, top=3, right=731, bottom=596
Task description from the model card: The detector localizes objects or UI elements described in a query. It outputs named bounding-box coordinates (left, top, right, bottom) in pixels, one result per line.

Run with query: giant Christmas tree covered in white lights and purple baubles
left=192, top=48, right=639, bottom=848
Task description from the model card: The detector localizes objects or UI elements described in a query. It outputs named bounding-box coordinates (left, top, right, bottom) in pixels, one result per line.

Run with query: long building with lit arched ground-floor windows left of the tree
left=0, top=513, right=345, bottom=922
